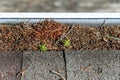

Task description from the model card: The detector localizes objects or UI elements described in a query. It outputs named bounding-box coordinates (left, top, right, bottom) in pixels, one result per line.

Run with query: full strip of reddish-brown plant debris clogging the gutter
left=0, top=20, right=120, bottom=51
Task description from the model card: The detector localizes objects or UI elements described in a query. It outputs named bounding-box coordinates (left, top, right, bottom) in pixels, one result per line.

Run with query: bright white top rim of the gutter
left=0, top=12, right=120, bottom=18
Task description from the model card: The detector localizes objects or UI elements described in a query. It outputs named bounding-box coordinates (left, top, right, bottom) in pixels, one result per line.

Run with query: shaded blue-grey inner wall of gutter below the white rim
left=0, top=18, right=120, bottom=25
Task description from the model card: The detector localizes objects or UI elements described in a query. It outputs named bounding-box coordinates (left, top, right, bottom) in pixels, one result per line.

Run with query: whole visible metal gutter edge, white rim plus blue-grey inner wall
left=0, top=12, right=120, bottom=25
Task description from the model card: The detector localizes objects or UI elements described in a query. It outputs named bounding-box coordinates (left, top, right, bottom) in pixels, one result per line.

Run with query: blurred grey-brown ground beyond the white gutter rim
left=0, top=0, right=120, bottom=12
